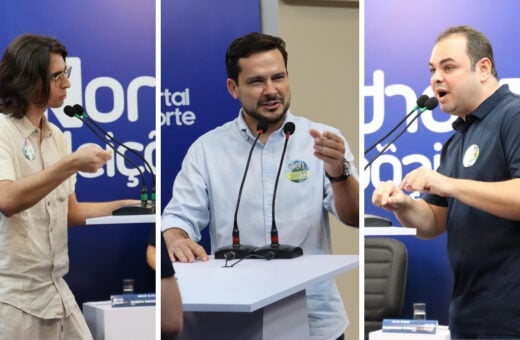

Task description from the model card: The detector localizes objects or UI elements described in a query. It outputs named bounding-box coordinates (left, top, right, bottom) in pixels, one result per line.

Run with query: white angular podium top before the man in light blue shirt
left=174, top=255, right=359, bottom=312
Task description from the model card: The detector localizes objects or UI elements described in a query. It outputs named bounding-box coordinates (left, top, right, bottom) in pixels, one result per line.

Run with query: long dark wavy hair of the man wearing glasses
left=0, top=33, right=67, bottom=118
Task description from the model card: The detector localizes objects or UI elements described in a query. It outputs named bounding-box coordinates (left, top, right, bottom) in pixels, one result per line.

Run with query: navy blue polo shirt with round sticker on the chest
left=424, top=85, right=520, bottom=337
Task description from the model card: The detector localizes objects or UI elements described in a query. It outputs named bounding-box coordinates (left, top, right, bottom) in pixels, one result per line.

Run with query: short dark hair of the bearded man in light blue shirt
left=226, top=32, right=287, bottom=84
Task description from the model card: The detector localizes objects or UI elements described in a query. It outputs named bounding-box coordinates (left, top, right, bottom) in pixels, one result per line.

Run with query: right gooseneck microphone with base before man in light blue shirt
left=254, top=122, right=303, bottom=259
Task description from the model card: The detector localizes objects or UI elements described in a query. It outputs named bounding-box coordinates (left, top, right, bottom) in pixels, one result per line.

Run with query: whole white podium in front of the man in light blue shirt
left=174, top=255, right=359, bottom=340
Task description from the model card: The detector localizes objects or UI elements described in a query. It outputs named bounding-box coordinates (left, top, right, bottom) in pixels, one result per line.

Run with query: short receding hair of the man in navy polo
left=436, top=25, right=498, bottom=79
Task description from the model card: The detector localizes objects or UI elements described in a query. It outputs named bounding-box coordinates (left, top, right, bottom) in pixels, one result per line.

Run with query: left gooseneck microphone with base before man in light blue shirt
left=214, top=120, right=269, bottom=260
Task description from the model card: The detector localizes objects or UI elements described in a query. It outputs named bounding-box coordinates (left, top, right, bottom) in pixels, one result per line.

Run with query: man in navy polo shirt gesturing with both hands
left=372, top=26, right=520, bottom=339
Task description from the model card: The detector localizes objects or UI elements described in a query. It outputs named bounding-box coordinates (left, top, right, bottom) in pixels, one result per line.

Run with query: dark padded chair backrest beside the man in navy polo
left=365, top=237, right=408, bottom=338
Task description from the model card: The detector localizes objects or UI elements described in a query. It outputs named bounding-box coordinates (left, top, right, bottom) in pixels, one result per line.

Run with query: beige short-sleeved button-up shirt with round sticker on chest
left=0, top=114, right=76, bottom=319
